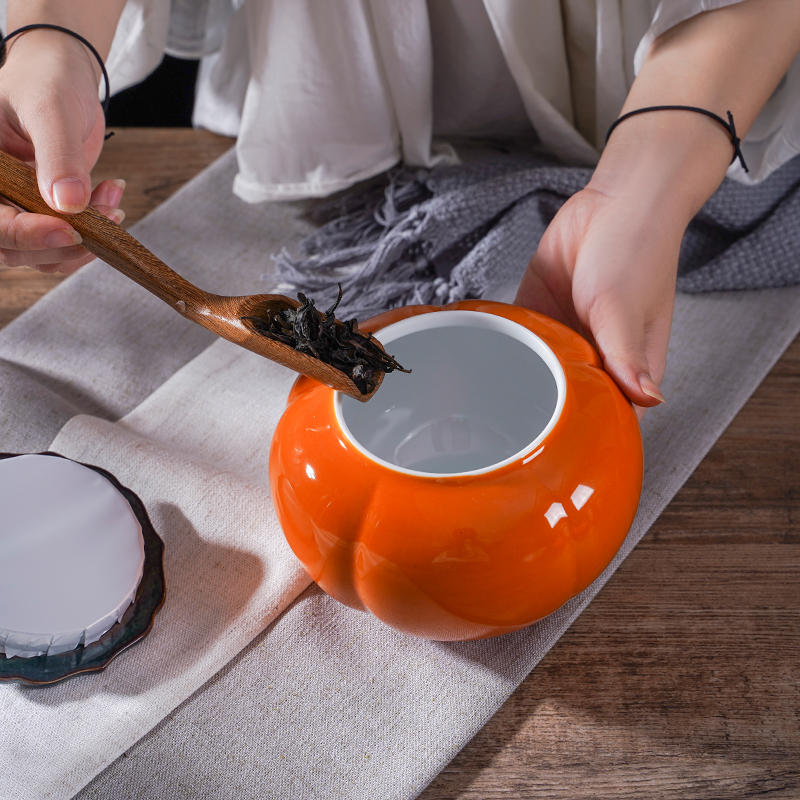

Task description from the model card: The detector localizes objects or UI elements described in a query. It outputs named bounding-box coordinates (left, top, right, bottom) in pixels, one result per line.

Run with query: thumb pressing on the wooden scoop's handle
left=27, top=97, right=92, bottom=214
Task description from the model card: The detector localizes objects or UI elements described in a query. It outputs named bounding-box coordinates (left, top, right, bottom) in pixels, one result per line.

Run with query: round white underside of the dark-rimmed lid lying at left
left=0, top=455, right=144, bottom=658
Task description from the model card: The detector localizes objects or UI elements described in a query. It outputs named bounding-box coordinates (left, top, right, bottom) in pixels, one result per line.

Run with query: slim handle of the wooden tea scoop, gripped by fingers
left=0, top=151, right=208, bottom=308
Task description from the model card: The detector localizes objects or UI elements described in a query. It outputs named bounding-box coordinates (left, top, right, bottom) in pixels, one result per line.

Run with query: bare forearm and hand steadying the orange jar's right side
left=532, top=0, right=800, bottom=413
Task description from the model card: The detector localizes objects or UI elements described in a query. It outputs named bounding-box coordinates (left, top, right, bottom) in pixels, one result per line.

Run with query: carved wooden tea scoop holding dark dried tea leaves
left=0, top=146, right=384, bottom=402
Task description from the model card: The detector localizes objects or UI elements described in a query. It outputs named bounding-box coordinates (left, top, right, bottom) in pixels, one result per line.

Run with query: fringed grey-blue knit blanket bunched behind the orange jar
left=277, top=152, right=800, bottom=318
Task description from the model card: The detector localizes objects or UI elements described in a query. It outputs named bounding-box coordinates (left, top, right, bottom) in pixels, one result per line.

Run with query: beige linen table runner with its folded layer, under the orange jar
left=0, top=147, right=800, bottom=800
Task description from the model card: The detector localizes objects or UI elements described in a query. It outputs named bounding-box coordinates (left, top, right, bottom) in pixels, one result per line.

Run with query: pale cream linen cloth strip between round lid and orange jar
left=0, top=341, right=311, bottom=798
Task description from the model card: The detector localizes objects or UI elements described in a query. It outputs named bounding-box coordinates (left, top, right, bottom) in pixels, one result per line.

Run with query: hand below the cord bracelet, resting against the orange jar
left=516, top=97, right=748, bottom=415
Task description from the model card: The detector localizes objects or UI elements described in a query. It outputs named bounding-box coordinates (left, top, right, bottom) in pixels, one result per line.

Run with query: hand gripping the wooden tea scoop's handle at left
left=0, top=29, right=125, bottom=272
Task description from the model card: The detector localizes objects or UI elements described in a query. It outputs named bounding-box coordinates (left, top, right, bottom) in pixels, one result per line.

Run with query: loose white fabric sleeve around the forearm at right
left=634, top=0, right=800, bottom=184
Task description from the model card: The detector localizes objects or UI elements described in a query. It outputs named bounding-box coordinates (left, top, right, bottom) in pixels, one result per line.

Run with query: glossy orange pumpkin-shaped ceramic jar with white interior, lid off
left=270, top=301, right=642, bottom=640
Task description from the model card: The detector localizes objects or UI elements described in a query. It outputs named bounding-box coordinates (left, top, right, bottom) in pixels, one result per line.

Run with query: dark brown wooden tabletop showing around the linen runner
left=0, top=129, right=800, bottom=800
